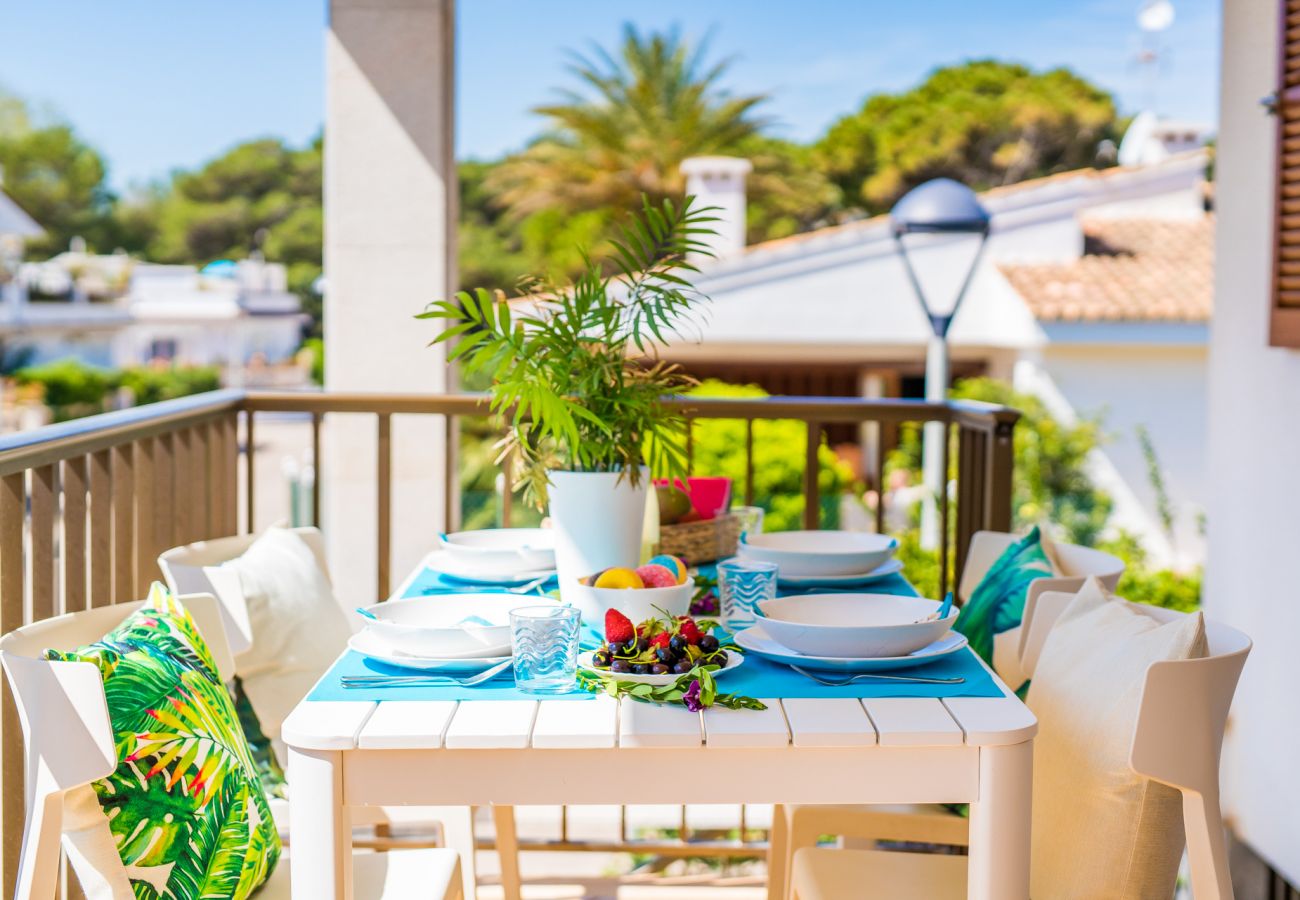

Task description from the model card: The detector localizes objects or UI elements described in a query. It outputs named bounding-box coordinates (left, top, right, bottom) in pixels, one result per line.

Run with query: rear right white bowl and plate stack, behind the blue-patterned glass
left=738, top=531, right=902, bottom=588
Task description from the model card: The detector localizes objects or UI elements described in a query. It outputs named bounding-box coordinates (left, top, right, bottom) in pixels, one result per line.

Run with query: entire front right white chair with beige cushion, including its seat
left=789, top=592, right=1251, bottom=900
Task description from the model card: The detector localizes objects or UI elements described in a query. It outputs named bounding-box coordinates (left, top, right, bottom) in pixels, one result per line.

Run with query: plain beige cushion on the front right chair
left=1028, top=577, right=1205, bottom=900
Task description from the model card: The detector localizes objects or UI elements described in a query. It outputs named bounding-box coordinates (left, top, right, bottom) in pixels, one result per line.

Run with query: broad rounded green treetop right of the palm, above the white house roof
left=816, top=60, right=1119, bottom=212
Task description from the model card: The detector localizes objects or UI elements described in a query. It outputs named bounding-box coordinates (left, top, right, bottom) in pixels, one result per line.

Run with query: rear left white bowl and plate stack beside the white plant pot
left=425, top=528, right=555, bottom=588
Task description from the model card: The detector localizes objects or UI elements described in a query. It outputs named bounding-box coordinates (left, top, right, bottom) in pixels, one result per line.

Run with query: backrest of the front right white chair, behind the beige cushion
left=1022, top=590, right=1251, bottom=900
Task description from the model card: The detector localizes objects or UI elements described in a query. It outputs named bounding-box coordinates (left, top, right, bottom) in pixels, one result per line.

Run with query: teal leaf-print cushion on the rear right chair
left=953, top=527, right=1054, bottom=666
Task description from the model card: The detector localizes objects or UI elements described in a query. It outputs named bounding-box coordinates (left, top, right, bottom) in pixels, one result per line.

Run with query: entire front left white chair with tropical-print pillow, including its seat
left=0, top=594, right=463, bottom=900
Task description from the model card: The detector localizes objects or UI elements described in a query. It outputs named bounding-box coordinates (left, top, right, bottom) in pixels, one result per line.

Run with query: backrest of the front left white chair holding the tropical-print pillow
left=0, top=594, right=234, bottom=900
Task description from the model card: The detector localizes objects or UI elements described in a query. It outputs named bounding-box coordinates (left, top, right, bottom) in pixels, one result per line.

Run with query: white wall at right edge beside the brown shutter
left=1205, top=0, right=1300, bottom=884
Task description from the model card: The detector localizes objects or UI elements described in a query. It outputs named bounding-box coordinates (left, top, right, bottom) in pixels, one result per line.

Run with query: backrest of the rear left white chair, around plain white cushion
left=159, top=528, right=329, bottom=655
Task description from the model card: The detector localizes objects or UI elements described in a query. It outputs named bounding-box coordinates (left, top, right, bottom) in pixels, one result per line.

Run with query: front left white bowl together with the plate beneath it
left=348, top=593, right=543, bottom=674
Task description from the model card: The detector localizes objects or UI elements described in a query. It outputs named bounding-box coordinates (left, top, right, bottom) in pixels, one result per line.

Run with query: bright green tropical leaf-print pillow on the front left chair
left=46, top=584, right=280, bottom=900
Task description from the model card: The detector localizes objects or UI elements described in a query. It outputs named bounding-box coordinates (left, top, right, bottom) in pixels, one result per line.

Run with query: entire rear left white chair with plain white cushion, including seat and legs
left=159, top=528, right=520, bottom=900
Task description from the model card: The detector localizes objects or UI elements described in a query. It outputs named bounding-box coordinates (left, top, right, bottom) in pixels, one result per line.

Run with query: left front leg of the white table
left=289, top=747, right=352, bottom=900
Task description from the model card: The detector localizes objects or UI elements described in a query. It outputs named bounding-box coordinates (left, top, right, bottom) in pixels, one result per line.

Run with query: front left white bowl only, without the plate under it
left=365, top=593, right=547, bottom=659
